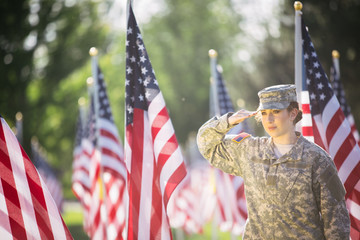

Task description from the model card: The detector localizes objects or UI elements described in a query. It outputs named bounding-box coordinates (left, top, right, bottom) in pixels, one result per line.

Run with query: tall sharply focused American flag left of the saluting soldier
left=125, top=6, right=186, bottom=240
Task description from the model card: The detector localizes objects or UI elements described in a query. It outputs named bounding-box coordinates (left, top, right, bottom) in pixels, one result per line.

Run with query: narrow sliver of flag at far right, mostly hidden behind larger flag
left=330, top=57, right=360, bottom=144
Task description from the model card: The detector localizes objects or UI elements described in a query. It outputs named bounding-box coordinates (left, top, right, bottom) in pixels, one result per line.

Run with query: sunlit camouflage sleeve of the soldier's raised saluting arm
left=197, top=113, right=242, bottom=176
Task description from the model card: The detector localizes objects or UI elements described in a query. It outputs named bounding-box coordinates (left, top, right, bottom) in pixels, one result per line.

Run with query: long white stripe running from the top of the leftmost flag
left=1, top=119, right=40, bottom=239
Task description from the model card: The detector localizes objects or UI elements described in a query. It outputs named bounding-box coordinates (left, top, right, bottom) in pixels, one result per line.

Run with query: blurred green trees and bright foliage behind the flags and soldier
left=0, top=0, right=360, bottom=239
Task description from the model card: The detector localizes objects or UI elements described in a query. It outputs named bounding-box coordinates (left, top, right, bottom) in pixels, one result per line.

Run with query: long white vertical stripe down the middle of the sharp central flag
left=137, top=111, right=154, bottom=239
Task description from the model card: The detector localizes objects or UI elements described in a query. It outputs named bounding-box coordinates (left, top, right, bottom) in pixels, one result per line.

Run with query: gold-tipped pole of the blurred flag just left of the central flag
left=89, top=47, right=108, bottom=239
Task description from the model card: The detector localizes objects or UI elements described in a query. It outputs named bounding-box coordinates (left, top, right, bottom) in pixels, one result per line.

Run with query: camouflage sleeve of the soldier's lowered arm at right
left=313, top=156, right=350, bottom=240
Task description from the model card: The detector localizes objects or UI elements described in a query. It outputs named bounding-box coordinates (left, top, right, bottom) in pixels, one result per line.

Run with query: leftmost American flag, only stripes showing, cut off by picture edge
left=0, top=116, right=72, bottom=239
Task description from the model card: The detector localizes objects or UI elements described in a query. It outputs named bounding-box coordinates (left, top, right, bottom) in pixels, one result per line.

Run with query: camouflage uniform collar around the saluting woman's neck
left=262, top=132, right=305, bottom=163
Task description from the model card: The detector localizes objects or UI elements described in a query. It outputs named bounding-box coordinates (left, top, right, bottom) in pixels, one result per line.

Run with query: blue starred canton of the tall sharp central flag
left=125, top=6, right=160, bottom=125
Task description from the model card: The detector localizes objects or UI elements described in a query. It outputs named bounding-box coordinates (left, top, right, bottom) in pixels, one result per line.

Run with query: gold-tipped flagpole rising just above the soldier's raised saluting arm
left=209, top=49, right=220, bottom=117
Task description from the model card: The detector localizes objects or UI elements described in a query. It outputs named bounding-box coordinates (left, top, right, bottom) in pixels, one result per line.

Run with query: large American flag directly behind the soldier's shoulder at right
left=302, top=19, right=360, bottom=239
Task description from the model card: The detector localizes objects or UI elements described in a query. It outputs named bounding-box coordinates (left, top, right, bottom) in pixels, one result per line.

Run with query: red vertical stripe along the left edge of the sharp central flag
left=126, top=108, right=144, bottom=240
